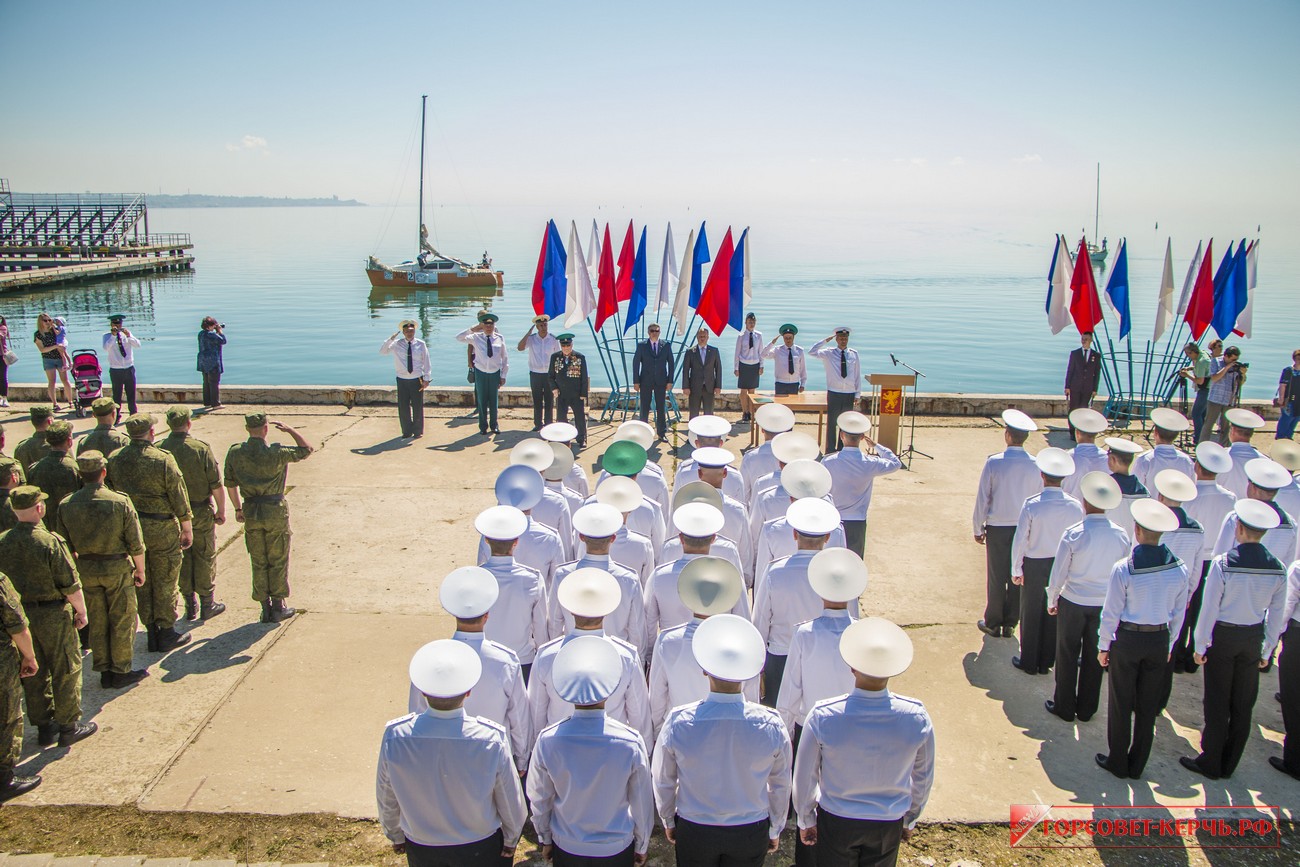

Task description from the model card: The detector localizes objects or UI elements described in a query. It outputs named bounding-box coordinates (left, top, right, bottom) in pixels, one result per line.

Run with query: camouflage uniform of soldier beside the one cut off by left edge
left=0, top=524, right=81, bottom=728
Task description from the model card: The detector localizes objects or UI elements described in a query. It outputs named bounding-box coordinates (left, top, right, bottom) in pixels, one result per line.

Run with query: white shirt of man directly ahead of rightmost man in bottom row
left=776, top=603, right=857, bottom=736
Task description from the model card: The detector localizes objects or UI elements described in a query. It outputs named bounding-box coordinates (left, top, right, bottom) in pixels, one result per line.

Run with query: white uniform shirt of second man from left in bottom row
left=528, top=708, right=654, bottom=858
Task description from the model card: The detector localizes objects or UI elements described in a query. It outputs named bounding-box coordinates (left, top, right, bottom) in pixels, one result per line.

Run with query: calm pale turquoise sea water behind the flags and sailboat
left=0, top=207, right=1300, bottom=398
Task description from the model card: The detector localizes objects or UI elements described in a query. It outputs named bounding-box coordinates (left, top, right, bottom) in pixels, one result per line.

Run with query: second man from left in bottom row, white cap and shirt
left=528, top=637, right=654, bottom=867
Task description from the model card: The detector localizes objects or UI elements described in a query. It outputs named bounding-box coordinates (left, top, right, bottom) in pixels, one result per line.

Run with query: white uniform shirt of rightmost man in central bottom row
left=794, top=689, right=935, bottom=828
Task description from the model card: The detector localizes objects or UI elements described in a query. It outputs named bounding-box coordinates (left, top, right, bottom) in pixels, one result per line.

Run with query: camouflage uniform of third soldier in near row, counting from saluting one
left=108, top=434, right=191, bottom=629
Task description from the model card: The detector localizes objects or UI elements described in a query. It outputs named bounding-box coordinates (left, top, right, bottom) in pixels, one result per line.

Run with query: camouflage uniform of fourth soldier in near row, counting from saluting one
left=59, top=475, right=144, bottom=675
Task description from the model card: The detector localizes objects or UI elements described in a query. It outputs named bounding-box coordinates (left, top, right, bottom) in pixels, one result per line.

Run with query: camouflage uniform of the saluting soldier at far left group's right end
left=226, top=437, right=312, bottom=603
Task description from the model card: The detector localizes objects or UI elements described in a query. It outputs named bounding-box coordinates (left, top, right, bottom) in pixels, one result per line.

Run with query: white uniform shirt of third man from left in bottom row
left=654, top=692, right=792, bottom=837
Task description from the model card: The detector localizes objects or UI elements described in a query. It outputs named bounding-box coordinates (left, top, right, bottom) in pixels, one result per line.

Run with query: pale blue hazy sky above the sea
left=0, top=0, right=1300, bottom=240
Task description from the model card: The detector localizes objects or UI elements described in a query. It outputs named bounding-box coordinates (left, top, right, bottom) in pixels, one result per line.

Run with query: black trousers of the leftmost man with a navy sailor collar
left=1106, top=628, right=1174, bottom=779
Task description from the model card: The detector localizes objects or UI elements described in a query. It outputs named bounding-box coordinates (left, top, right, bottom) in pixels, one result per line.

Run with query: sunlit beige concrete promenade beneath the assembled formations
left=0, top=400, right=1300, bottom=822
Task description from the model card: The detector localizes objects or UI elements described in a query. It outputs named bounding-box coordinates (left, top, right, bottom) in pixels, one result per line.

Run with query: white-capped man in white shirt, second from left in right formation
left=1011, top=448, right=1083, bottom=675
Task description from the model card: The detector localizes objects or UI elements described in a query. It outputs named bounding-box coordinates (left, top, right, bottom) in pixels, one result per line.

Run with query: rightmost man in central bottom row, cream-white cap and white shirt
left=794, top=617, right=935, bottom=867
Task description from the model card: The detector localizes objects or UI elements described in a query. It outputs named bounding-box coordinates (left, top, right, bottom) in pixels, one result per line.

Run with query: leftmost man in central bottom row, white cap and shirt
left=374, top=638, right=528, bottom=867
